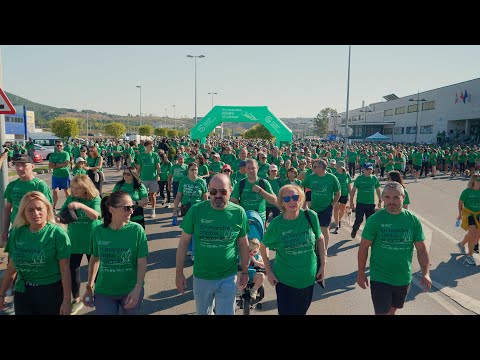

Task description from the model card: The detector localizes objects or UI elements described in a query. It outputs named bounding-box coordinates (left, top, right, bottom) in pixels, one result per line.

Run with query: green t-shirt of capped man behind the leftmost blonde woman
left=3, top=178, right=53, bottom=224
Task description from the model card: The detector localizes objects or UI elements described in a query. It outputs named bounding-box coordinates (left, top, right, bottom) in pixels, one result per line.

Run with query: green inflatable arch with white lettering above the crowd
left=190, top=106, right=293, bottom=146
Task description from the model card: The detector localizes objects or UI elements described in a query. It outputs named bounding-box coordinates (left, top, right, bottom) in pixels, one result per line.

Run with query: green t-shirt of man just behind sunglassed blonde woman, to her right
left=303, top=173, right=340, bottom=212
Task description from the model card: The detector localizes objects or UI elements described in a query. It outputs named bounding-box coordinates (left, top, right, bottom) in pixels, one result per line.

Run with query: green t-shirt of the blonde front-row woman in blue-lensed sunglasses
left=262, top=210, right=321, bottom=289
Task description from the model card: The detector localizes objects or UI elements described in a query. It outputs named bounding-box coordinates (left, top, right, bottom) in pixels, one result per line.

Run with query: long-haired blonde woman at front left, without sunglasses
left=0, top=191, right=71, bottom=315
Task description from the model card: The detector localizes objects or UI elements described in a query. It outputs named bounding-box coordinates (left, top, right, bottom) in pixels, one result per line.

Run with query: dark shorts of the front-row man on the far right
left=370, top=281, right=410, bottom=314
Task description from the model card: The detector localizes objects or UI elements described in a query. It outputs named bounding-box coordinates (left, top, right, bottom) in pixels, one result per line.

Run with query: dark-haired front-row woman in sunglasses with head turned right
left=83, top=191, right=148, bottom=315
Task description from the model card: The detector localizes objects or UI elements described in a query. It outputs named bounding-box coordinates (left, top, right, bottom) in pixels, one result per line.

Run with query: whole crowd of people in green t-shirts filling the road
left=0, top=137, right=480, bottom=315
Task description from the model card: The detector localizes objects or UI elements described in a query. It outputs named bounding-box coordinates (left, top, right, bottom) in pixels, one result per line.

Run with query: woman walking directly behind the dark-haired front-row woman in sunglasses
left=113, top=165, right=148, bottom=229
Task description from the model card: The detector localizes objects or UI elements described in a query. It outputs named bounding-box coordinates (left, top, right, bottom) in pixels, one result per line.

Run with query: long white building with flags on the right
left=328, top=79, right=480, bottom=143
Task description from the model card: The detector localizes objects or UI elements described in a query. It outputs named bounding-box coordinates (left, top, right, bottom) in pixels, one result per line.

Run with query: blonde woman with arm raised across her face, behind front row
left=58, top=175, right=101, bottom=315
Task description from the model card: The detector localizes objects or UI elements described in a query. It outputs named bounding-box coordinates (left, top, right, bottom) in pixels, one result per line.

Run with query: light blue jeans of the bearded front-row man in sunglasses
left=193, top=274, right=237, bottom=315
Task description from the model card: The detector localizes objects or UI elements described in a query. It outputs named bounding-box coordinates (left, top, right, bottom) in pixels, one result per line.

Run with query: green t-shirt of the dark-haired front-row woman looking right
left=92, top=221, right=148, bottom=296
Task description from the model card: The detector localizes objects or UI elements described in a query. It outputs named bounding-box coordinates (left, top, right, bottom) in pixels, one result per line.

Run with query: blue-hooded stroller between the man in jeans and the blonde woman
left=237, top=210, right=265, bottom=315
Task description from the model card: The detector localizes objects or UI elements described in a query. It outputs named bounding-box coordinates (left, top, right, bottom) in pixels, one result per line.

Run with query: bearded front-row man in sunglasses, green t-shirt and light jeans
left=175, top=174, right=249, bottom=315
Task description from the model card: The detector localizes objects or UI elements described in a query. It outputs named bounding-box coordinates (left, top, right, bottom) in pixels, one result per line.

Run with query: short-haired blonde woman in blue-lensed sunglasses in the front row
left=260, top=185, right=326, bottom=315
